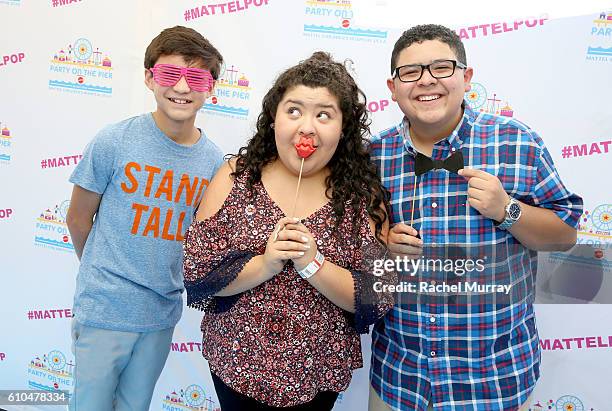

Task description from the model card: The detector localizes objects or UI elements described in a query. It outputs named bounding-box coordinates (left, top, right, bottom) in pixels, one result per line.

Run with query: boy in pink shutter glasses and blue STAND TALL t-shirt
left=67, top=26, right=223, bottom=411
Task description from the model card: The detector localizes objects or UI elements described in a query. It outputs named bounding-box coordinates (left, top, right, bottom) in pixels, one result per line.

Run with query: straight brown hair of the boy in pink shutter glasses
left=145, top=26, right=223, bottom=80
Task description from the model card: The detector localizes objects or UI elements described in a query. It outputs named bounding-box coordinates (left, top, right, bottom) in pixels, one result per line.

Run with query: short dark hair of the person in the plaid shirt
left=391, top=24, right=467, bottom=75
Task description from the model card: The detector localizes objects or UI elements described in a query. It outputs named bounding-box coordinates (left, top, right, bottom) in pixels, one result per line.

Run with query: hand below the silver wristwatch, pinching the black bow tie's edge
left=459, top=168, right=510, bottom=221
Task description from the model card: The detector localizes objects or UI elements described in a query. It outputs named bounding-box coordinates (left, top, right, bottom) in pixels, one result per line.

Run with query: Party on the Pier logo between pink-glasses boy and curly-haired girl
left=201, top=64, right=252, bottom=120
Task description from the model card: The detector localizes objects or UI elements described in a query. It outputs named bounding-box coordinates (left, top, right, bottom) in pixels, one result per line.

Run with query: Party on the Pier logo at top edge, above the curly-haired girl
left=304, top=0, right=387, bottom=43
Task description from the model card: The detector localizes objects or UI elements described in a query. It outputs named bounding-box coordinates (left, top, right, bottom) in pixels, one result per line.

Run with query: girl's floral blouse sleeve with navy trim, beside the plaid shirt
left=351, top=209, right=397, bottom=334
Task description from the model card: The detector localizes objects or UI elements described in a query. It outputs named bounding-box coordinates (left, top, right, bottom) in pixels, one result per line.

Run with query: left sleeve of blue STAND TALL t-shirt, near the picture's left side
left=69, top=127, right=117, bottom=194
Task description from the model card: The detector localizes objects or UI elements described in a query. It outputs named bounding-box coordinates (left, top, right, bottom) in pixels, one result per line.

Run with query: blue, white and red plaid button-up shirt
left=370, top=103, right=582, bottom=411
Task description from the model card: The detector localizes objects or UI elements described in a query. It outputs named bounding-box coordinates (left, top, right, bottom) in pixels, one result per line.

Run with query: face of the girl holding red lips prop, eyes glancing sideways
left=274, top=85, right=342, bottom=176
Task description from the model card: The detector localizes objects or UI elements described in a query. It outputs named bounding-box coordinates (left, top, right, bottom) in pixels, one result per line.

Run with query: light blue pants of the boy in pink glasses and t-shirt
left=69, top=320, right=174, bottom=411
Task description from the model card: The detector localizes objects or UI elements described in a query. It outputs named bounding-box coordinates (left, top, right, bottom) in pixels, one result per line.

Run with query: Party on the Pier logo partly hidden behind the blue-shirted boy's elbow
left=34, top=200, right=74, bottom=252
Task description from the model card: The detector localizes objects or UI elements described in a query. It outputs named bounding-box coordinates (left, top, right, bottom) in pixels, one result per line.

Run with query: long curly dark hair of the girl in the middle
left=231, top=51, right=389, bottom=239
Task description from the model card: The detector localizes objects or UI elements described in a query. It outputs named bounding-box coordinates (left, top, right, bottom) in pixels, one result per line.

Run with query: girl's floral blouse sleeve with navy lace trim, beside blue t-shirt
left=183, top=214, right=256, bottom=310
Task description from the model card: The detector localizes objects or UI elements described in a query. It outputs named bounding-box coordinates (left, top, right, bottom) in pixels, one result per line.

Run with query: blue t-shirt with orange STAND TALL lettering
left=70, top=113, right=223, bottom=332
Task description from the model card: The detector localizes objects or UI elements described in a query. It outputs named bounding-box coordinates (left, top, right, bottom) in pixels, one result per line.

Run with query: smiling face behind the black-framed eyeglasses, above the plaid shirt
left=387, top=40, right=473, bottom=138
